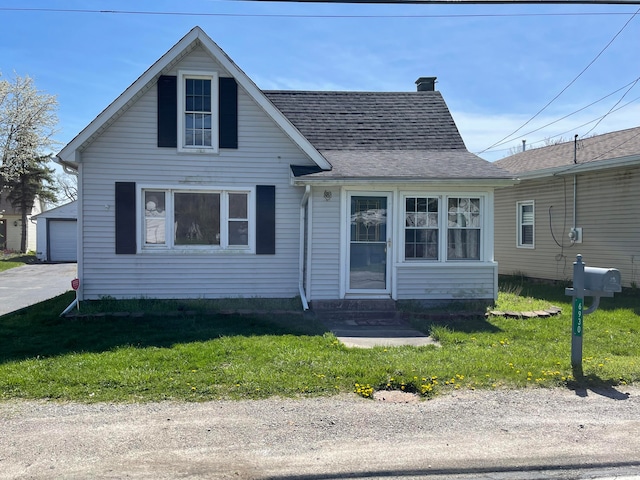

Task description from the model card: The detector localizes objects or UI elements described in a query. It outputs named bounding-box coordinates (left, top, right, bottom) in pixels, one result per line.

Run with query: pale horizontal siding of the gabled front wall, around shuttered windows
left=79, top=48, right=310, bottom=299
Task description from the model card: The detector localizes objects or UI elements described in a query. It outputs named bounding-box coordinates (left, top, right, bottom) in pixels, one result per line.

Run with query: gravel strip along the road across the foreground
left=0, top=387, right=640, bottom=480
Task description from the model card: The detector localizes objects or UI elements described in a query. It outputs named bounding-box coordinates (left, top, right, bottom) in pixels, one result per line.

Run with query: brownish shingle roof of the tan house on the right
left=494, top=127, right=640, bottom=174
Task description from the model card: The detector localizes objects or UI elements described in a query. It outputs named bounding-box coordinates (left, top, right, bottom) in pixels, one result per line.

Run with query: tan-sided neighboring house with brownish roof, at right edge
left=495, top=127, right=640, bottom=287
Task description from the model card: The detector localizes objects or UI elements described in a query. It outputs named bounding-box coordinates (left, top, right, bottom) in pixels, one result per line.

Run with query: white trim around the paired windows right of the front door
left=396, top=190, right=492, bottom=267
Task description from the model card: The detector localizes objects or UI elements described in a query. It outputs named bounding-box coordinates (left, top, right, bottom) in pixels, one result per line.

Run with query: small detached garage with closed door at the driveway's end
left=34, top=201, right=78, bottom=262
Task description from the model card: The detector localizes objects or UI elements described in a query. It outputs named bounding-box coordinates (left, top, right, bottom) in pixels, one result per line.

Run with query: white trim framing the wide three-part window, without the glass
left=136, top=185, right=256, bottom=254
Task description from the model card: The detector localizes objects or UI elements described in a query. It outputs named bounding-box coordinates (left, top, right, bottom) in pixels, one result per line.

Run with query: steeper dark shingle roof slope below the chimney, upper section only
left=264, top=91, right=466, bottom=150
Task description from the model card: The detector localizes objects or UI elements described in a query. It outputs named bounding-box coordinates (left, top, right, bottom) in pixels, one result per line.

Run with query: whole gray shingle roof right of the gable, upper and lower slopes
left=264, top=91, right=512, bottom=179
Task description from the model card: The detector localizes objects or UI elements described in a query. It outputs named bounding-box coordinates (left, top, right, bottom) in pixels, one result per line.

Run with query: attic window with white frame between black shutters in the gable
left=178, top=71, right=218, bottom=153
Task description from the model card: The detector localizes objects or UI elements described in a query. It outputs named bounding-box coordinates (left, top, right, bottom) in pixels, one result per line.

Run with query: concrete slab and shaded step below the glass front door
left=311, top=299, right=437, bottom=348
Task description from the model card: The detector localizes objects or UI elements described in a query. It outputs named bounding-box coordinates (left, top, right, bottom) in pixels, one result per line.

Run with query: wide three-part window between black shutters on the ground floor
left=142, top=189, right=253, bottom=250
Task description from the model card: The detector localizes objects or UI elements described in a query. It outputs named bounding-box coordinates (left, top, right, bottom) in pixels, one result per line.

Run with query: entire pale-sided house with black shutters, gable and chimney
left=57, top=27, right=512, bottom=307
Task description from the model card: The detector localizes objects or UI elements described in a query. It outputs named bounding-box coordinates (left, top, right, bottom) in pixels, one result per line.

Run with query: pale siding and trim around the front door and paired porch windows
left=307, top=185, right=498, bottom=301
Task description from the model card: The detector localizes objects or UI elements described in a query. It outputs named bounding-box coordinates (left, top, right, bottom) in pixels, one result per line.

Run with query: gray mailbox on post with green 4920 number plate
left=565, top=255, right=622, bottom=372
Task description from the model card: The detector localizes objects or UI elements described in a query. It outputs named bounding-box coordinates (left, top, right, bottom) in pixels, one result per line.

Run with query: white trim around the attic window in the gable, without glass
left=178, top=70, right=220, bottom=154
